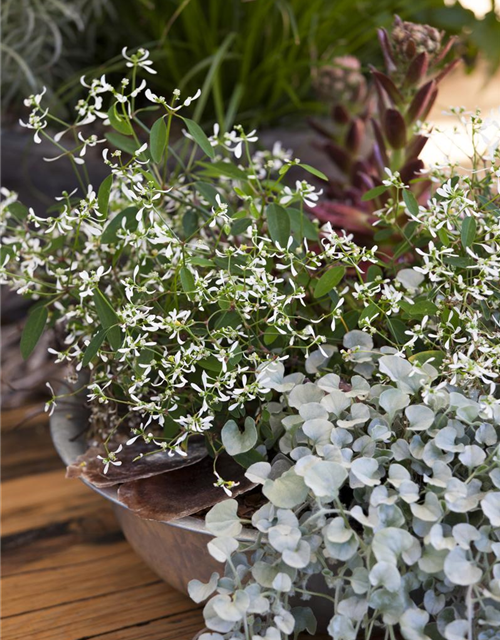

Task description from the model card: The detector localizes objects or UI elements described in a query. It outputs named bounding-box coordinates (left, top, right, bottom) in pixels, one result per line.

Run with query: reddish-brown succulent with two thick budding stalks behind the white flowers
left=311, top=16, right=459, bottom=242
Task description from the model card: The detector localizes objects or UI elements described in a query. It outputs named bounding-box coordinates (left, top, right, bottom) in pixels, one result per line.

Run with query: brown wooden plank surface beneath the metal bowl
left=0, top=406, right=203, bottom=640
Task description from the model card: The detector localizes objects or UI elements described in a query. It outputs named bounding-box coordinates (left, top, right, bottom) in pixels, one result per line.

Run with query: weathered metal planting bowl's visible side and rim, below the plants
left=50, top=396, right=332, bottom=629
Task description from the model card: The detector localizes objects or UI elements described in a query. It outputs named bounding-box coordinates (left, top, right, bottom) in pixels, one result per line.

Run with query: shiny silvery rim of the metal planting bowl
left=50, top=396, right=257, bottom=540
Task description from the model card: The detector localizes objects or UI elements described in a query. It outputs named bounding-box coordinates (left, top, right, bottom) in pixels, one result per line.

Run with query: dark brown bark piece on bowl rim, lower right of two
left=118, top=455, right=255, bottom=522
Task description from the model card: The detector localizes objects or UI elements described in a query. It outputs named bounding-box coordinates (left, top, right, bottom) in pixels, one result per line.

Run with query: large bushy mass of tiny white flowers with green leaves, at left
left=0, top=50, right=350, bottom=465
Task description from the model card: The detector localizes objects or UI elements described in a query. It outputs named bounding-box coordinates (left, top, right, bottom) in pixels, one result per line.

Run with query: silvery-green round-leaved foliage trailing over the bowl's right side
left=195, top=332, right=500, bottom=640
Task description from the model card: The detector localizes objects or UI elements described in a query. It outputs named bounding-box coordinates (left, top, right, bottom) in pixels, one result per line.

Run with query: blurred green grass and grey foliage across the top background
left=0, top=0, right=500, bottom=126
